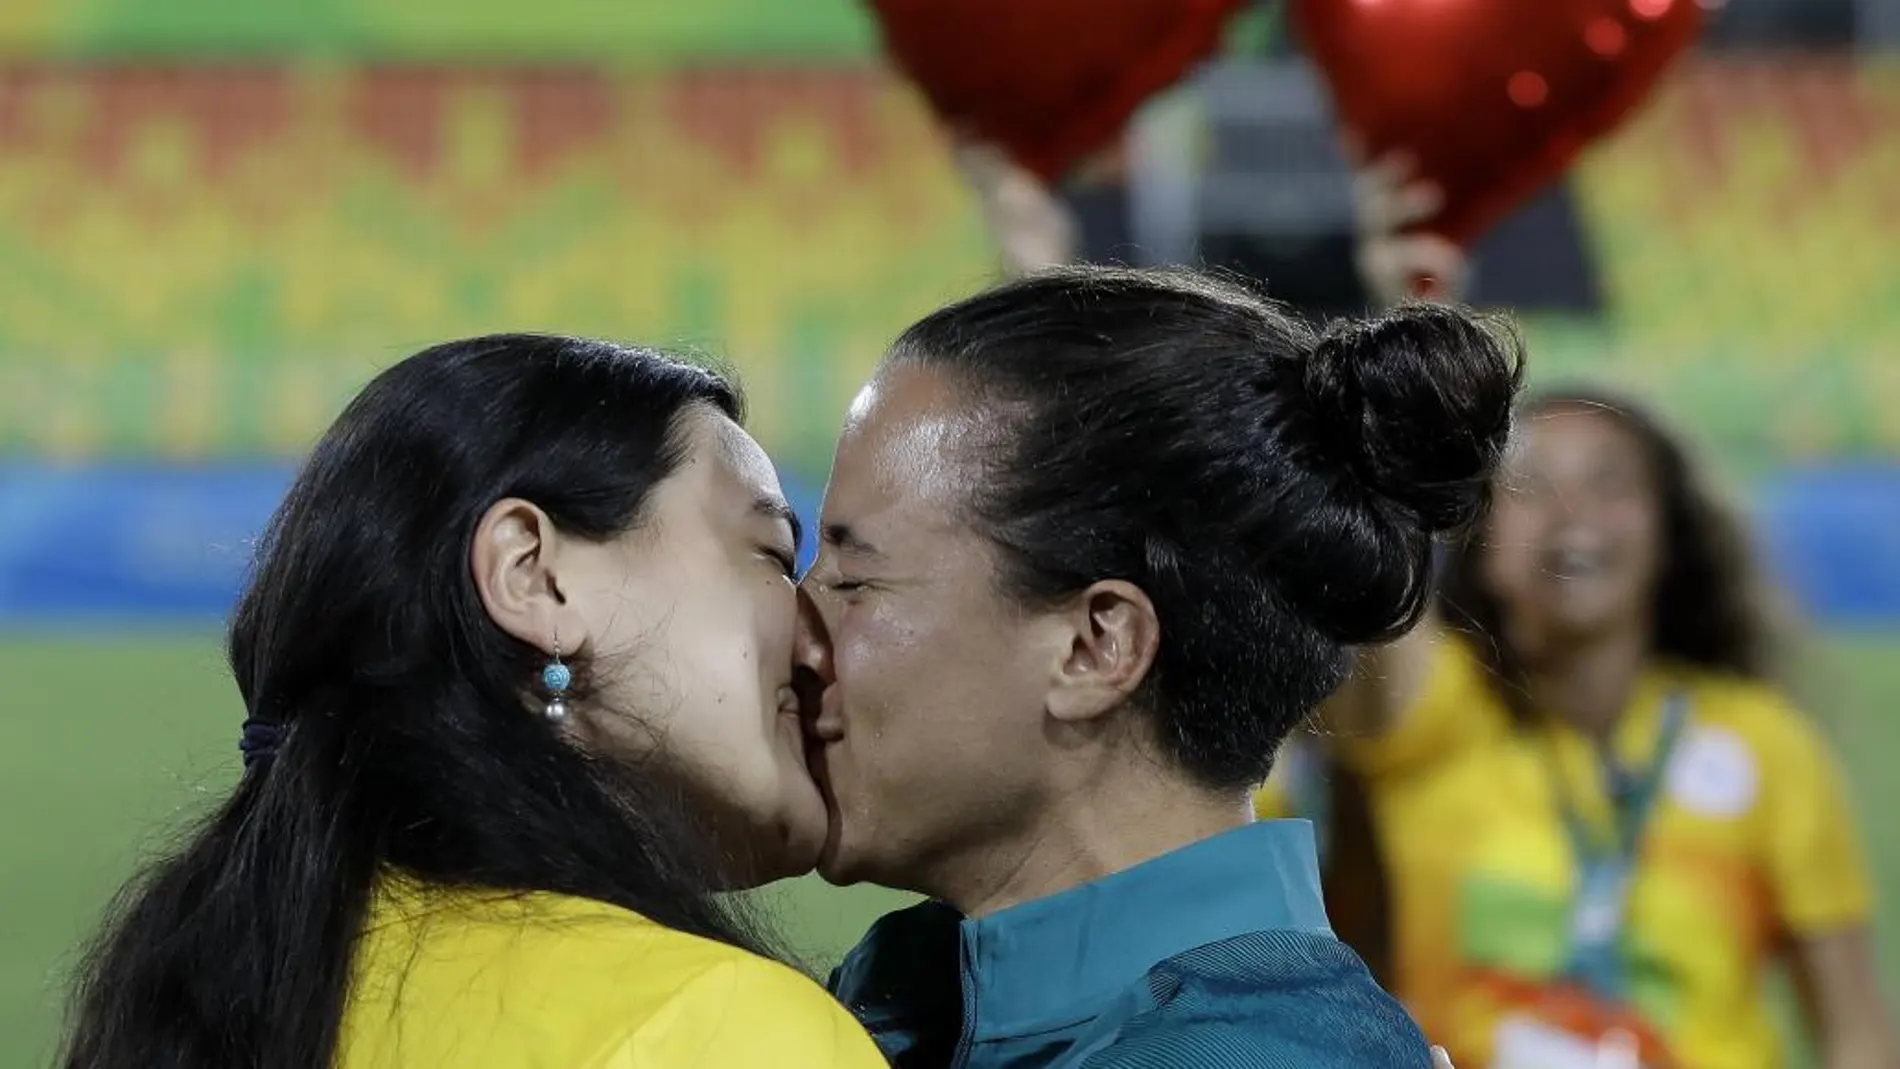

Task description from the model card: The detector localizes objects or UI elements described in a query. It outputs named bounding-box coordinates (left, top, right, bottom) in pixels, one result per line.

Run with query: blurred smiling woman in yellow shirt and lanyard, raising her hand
left=1262, top=152, right=1900, bottom=1069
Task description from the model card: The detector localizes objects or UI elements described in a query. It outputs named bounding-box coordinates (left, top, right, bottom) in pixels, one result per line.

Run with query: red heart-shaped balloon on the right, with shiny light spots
left=1292, top=0, right=1701, bottom=245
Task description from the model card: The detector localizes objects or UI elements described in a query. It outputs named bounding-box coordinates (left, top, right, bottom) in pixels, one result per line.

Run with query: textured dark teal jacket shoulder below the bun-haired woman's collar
left=1083, top=930, right=1431, bottom=1069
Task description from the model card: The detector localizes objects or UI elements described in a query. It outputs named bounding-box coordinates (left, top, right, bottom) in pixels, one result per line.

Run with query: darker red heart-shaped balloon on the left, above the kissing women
left=868, top=0, right=1250, bottom=180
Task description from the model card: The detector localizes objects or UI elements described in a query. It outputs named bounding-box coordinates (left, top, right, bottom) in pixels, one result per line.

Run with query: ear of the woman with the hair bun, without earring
left=1047, top=579, right=1161, bottom=722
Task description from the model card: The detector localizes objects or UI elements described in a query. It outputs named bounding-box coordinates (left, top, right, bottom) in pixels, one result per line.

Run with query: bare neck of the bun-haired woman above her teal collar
left=918, top=758, right=1252, bottom=917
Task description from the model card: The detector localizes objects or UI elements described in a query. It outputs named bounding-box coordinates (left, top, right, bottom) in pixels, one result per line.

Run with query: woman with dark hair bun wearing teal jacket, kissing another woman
left=802, top=268, right=1520, bottom=1069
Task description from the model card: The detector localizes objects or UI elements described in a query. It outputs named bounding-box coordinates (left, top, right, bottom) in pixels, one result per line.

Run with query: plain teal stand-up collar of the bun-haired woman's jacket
left=960, top=820, right=1330, bottom=1042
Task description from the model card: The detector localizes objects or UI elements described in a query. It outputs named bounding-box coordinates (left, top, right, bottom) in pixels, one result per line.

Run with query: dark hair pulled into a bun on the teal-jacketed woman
left=889, top=268, right=1522, bottom=790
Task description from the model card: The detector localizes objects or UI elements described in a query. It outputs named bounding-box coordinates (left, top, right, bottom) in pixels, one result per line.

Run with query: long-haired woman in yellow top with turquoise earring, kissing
left=63, top=336, right=884, bottom=1069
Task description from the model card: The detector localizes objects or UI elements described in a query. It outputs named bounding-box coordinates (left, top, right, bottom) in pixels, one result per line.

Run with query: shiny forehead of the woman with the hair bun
left=825, top=363, right=986, bottom=545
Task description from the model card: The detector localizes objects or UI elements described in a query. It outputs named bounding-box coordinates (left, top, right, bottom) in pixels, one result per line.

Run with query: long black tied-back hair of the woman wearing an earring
left=63, top=334, right=758, bottom=1069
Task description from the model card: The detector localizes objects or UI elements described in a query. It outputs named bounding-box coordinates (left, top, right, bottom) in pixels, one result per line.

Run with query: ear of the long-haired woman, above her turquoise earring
left=469, top=497, right=587, bottom=655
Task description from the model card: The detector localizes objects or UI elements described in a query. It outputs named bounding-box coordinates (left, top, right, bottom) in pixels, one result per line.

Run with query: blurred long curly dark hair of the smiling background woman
left=1438, top=389, right=1777, bottom=712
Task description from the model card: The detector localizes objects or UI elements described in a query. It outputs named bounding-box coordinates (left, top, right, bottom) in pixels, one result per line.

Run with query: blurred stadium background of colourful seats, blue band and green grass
left=0, top=0, right=1900, bottom=1065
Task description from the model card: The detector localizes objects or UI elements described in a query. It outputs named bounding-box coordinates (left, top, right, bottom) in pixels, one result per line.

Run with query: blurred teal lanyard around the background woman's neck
left=1547, top=693, right=1689, bottom=1001
